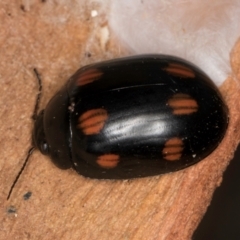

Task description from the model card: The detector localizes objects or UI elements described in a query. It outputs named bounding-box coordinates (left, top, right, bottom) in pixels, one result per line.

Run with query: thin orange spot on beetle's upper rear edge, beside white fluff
left=163, top=63, right=195, bottom=78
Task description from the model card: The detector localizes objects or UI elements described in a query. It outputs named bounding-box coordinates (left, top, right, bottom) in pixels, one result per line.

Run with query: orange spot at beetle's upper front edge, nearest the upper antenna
left=76, top=68, right=103, bottom=86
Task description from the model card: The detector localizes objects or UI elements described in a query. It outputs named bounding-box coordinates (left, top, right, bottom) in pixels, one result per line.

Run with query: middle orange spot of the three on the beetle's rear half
left=167, top=93, right=198, bottom=115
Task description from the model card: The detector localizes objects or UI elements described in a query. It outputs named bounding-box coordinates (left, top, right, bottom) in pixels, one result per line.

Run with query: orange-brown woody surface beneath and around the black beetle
left=0, top=1, right=240, bottom=240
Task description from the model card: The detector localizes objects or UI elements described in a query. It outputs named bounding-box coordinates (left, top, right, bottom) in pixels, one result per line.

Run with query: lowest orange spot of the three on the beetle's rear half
left=162, top=137, right=184, bottom=161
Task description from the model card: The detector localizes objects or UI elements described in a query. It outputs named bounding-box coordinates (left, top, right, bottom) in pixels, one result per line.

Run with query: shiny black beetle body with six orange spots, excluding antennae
left=33, top=55, right=228, bottom=179
